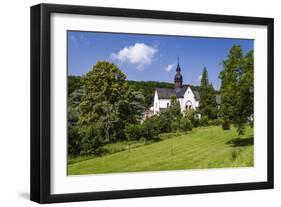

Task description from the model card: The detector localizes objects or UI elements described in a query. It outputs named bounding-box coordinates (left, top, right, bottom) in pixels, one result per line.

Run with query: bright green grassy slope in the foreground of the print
left=68, top=126, right=254, bottom=175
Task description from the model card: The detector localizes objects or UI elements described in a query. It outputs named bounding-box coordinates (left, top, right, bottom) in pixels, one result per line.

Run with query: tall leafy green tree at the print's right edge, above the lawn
left=219, top=45, right=254, bottom=134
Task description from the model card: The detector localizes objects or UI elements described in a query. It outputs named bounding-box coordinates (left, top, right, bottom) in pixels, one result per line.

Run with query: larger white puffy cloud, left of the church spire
left=110, top=43, right=157, bottom=70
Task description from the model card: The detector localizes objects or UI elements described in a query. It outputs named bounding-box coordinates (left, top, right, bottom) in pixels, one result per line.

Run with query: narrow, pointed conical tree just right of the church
left=199, top=67, right=217, bottom=119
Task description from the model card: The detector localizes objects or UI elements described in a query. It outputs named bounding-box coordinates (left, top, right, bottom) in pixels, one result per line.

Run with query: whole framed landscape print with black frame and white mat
left=31, top=4, right=273, bottom=203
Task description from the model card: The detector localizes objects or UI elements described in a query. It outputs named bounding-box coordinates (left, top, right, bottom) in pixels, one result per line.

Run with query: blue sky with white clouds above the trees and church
left=67, top=31, right=254, bottom=89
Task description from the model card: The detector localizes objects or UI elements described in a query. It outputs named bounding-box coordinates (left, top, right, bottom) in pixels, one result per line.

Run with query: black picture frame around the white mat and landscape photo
left=30, top=4, right=274, bottom=203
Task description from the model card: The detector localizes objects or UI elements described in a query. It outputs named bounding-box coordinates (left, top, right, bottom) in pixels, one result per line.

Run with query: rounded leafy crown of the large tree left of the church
left=79, top=62, right=129, bottom=124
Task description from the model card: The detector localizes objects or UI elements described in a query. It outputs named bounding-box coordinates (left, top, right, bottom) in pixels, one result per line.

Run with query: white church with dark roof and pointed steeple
left=150, top=58, right=220, bottom=117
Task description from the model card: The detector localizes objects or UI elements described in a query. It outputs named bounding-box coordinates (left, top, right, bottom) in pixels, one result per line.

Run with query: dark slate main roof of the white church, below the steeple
left=156, top=85, right=197, bottom=100
